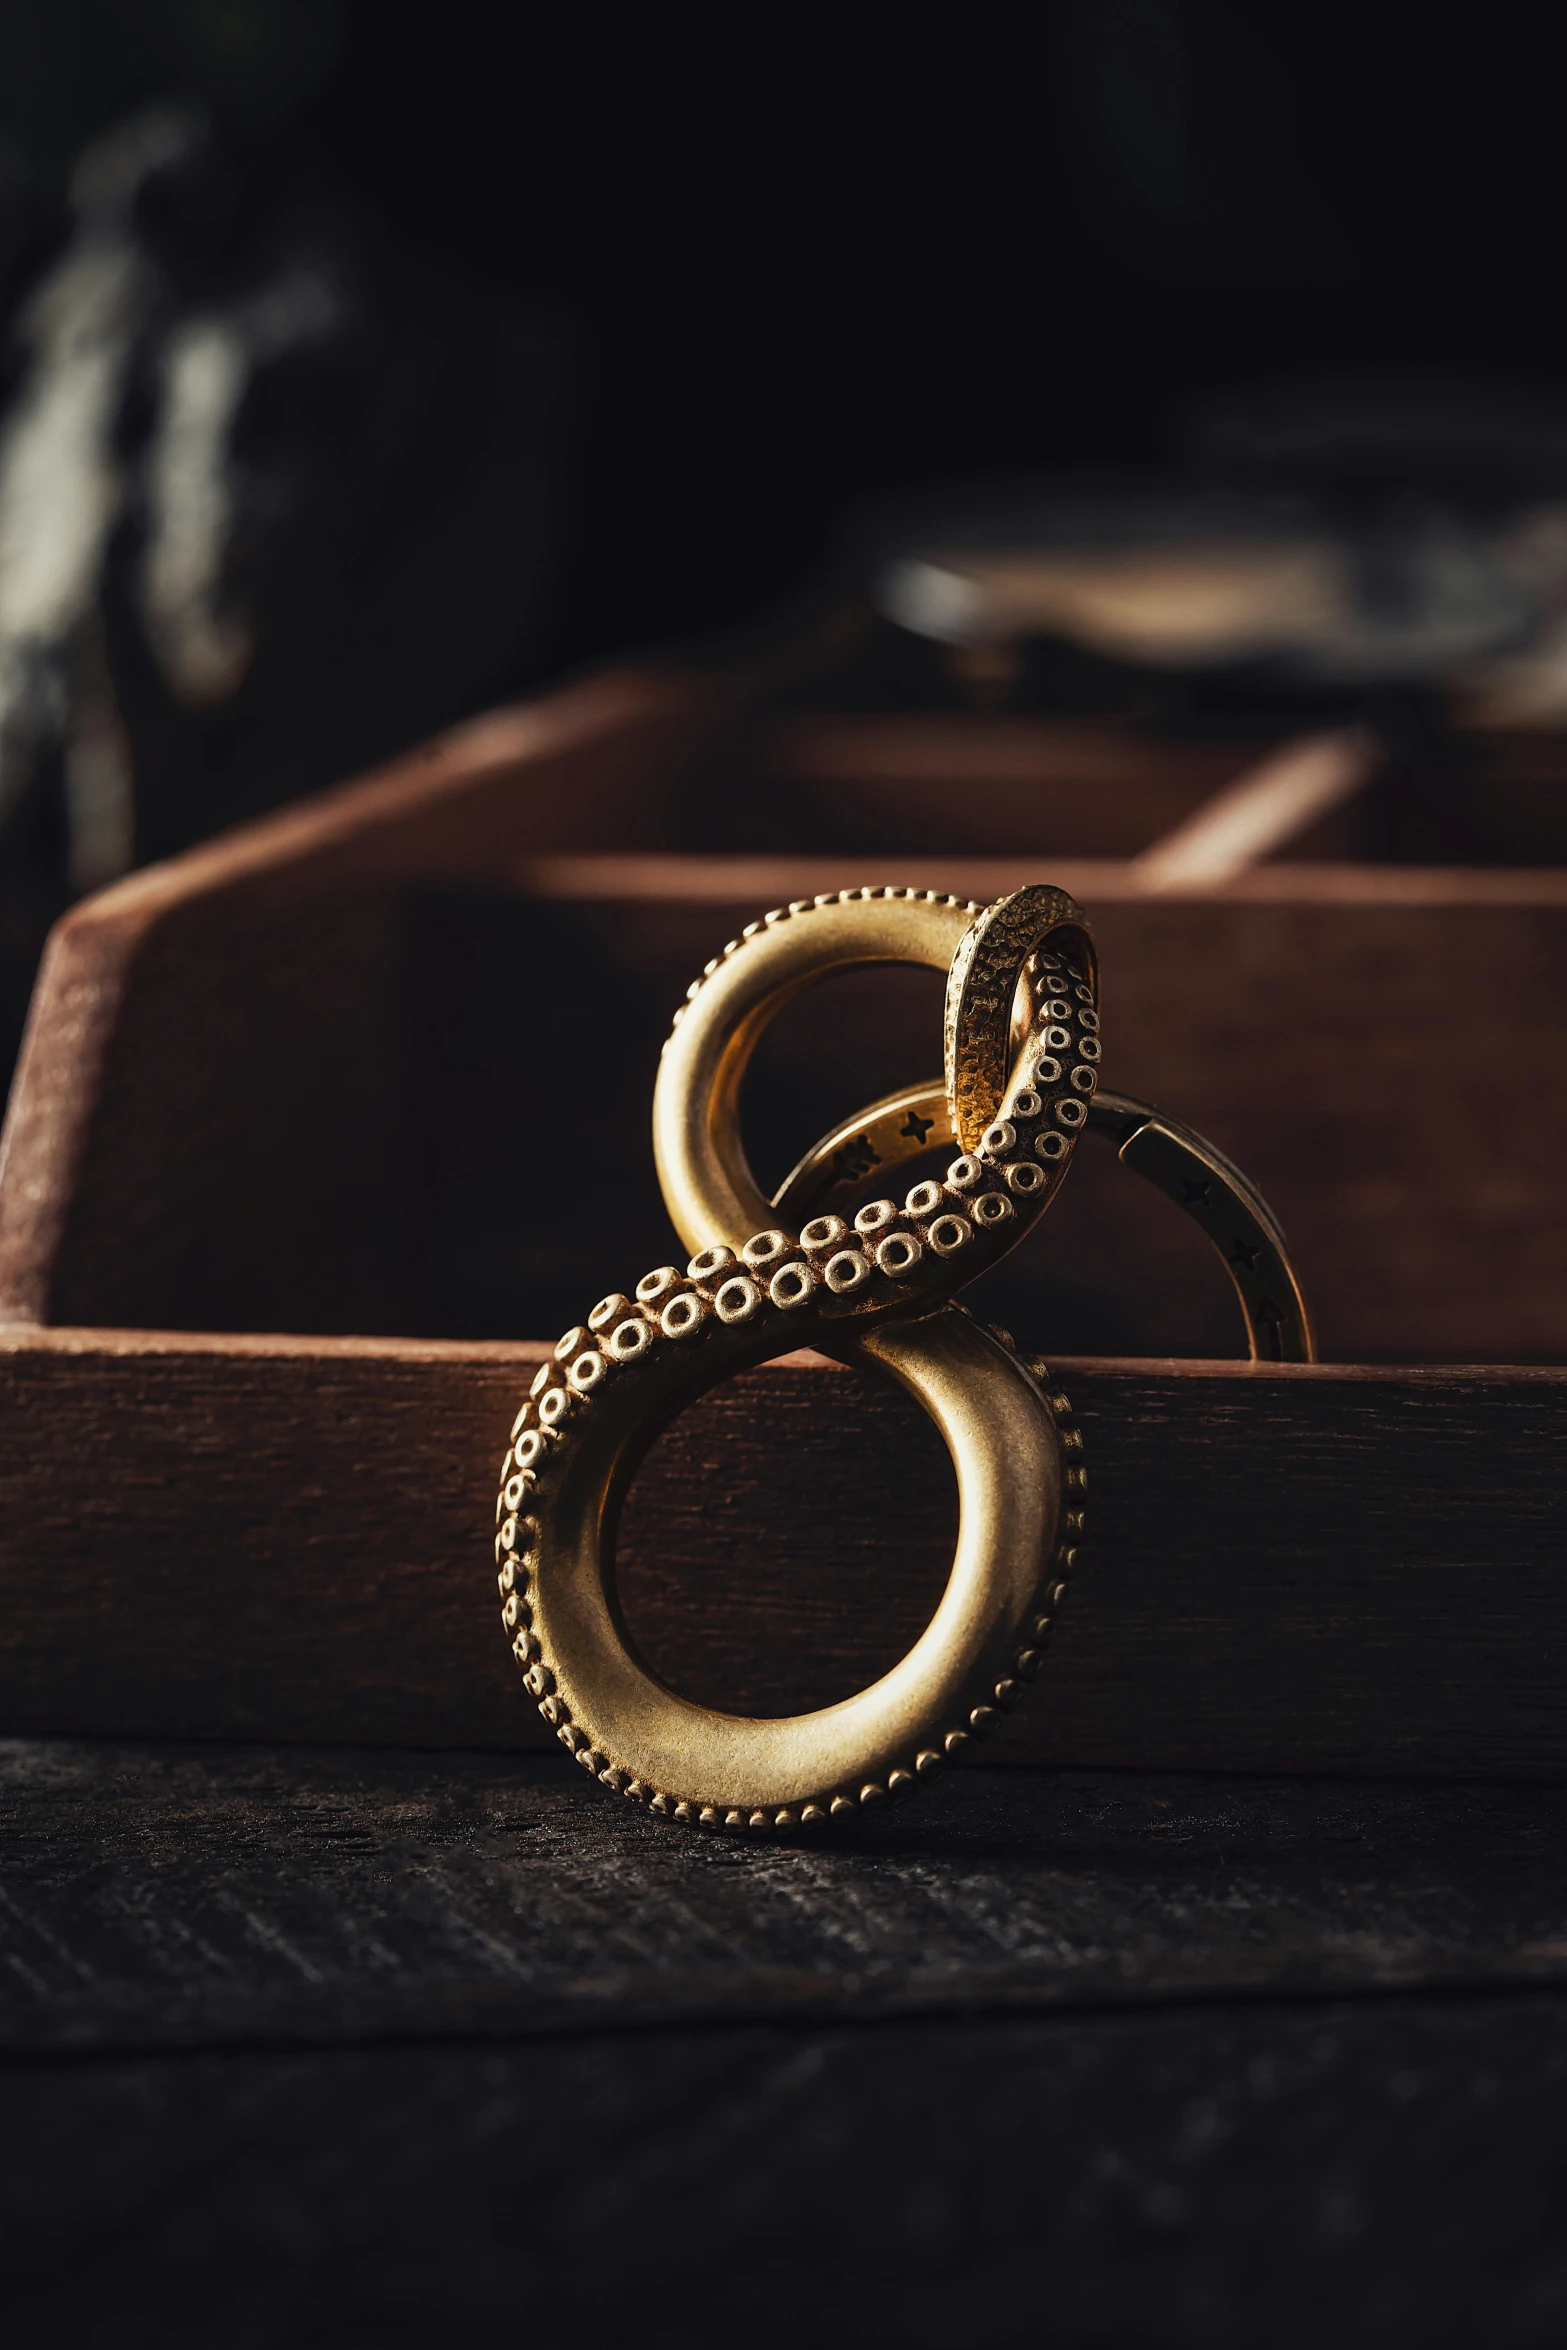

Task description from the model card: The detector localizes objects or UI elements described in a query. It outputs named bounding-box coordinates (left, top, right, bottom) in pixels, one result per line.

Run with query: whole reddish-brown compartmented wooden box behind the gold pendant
left=0, top=670, right=1567, bottom=1774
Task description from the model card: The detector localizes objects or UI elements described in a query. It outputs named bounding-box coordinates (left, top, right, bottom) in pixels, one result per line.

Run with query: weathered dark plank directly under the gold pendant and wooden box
left=0, top=1741, right=1567, bottom=2054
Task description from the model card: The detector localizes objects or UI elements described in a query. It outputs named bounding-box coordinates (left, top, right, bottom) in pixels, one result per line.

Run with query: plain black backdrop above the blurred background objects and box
left=0, top=0, right=1567, bottom=684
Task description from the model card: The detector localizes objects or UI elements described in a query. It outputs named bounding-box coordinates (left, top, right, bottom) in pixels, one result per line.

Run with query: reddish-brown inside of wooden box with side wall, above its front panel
left=0, top=662, right=1567, bottom=1363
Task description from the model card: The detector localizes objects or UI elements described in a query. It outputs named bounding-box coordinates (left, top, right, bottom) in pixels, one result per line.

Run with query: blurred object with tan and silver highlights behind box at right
left=855, top=399, right=1567, bottom=705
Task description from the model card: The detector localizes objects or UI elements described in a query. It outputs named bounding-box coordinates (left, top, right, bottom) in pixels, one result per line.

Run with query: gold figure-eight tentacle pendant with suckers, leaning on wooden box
left=496, top=886, right=1097, bottom=1831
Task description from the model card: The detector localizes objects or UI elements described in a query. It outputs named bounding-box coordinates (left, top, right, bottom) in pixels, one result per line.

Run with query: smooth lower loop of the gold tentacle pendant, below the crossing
left=500, top=1309, right=1062, bottom=1831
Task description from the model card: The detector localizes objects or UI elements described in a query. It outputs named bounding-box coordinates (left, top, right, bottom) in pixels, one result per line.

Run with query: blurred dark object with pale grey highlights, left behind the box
left=0, top=0, right=576, bottom=1076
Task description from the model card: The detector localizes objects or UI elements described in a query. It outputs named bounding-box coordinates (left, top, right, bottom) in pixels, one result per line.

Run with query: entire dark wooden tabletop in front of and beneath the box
left=0, top=1741, right=1567, bottom=2350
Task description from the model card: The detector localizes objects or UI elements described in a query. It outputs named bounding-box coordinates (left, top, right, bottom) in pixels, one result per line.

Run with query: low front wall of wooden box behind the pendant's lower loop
left=0, top=1330, right=1567, bottom=1777
